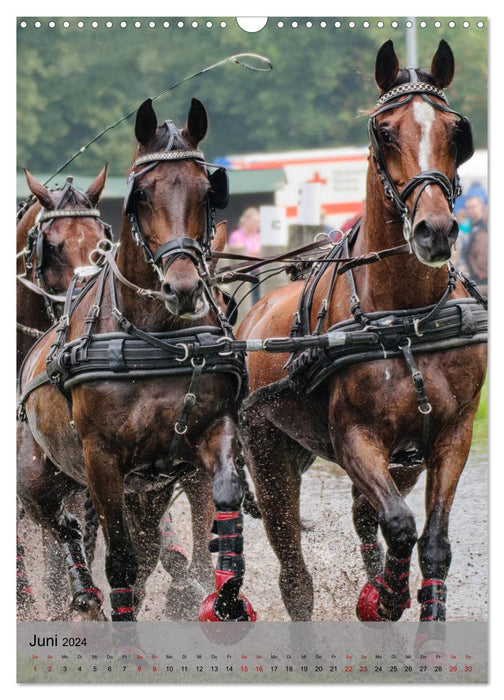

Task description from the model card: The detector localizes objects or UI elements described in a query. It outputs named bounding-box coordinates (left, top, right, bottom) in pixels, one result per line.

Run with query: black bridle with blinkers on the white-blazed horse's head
left=368, top=69, right=474, bottom=252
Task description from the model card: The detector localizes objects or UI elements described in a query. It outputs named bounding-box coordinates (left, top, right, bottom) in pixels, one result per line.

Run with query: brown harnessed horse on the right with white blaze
left=238, top=41, right=486, bottom=621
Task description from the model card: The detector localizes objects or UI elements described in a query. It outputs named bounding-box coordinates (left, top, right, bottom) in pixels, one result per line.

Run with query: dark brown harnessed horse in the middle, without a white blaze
left=18, top=100, right=253, bottom=620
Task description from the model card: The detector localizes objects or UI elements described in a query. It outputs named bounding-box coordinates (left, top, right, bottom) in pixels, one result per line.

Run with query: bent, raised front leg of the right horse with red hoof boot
left=341, top=427, right=417, bottom=622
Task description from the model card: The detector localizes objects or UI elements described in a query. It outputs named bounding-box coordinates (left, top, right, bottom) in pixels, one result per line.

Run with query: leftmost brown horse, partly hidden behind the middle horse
left=16, top=166, right=110, bottom=371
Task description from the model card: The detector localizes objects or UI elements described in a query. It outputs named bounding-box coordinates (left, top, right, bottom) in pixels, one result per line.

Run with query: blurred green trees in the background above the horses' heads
left=17, top=17, right=487, bottom=175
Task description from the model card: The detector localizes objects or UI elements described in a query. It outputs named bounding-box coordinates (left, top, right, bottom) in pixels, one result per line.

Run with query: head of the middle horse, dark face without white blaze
left=124, top=99, right=227, bottom=320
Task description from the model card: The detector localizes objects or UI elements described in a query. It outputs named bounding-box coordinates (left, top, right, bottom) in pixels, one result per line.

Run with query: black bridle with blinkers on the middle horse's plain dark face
left=124, top=120, right=229, bottom=281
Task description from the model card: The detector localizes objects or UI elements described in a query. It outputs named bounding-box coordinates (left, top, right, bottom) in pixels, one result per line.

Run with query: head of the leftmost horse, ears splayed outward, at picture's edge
left=20, top=166, right=107, bottom=294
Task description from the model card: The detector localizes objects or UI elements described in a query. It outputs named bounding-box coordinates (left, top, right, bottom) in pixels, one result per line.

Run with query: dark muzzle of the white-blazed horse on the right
left=412, top=217, right=459, bottom=267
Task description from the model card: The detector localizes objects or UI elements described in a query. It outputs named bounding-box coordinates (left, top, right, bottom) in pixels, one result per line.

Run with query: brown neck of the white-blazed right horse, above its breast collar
left=354, top=163, right=448, bottom=311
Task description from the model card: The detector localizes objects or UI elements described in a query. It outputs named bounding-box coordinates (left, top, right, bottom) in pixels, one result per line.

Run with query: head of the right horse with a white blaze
left=369, top=40, right=473, bottom=267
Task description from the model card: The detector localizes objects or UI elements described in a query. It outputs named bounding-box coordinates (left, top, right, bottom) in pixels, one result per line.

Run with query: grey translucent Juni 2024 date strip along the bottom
left=18, top=622, right=488, bottom=684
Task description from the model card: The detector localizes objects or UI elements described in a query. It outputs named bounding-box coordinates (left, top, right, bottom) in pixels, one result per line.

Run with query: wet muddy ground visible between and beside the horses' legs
left=17, top=445, right=488, bottom=621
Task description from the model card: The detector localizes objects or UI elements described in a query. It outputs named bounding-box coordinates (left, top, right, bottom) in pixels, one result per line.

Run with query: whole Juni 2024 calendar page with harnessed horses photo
left=16, top=13, right=489, bottom=684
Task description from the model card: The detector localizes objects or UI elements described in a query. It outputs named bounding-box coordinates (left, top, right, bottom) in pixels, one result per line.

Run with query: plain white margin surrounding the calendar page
left=0, top=0, right=504, bottom=700
